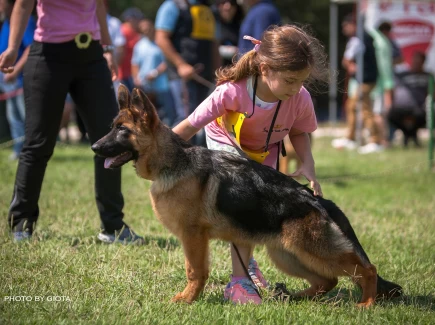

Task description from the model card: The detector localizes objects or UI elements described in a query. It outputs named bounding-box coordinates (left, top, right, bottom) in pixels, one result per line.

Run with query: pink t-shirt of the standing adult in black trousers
left=34, top=0, right=100, bottom=43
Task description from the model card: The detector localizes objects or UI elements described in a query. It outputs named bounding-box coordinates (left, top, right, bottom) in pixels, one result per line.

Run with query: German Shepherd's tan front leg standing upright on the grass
left=172, top=227, right=209, bottom=303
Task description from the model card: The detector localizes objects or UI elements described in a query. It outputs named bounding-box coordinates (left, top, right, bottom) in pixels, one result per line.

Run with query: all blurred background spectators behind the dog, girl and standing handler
left=0, top=0, right=430, bottom=160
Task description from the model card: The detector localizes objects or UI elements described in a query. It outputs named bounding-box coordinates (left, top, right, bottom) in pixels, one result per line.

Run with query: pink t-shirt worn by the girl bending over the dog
left=188, top=79, right=317, bottom=165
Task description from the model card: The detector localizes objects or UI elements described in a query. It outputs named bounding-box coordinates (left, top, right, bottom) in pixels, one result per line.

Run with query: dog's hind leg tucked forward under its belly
left=268, top=247, right=338, bottom=297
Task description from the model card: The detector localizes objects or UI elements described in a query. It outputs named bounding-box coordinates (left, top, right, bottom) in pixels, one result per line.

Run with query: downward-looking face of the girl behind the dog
left=260, top=67, right=311, bottom=100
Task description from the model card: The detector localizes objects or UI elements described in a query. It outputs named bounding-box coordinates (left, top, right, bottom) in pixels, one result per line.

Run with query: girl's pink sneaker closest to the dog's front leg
left=224, top=278, right=261, bottom=305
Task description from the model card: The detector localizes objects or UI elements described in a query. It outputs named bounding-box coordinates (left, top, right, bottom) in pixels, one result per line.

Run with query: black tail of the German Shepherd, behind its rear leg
left=319, top=198, right=403, bottom=298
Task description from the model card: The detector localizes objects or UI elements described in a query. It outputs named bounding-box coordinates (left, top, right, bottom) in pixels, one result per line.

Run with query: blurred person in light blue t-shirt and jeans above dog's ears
left=131, top=19, right=175, bottom=126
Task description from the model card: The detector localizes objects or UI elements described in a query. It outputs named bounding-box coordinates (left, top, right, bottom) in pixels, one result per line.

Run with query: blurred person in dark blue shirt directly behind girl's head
left=238, top=0, right=281, bottom=54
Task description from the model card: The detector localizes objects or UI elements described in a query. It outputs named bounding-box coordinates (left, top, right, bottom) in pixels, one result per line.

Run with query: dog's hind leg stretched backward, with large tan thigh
left=278, top=212, right=377, bottom=307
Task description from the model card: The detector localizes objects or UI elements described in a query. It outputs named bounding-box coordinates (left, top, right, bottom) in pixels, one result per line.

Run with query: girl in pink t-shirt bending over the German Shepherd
left=174, top=25, right=328, bottom=304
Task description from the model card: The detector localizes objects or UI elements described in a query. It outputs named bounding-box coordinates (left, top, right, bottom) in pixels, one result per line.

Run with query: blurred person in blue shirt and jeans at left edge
left=0, top=0, right=36, bottom=160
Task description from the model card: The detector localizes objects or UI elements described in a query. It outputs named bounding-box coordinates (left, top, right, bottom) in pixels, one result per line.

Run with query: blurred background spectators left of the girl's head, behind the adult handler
left=0, top=0, right=281, bottom=160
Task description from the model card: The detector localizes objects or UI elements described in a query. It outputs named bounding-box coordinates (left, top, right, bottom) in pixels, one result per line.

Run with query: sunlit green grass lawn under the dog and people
left=0, top=138, right=435, bottom=324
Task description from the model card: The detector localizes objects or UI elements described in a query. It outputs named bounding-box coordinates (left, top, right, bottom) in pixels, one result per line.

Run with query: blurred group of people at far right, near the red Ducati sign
left=332, top=14, right=431, bottom=154
